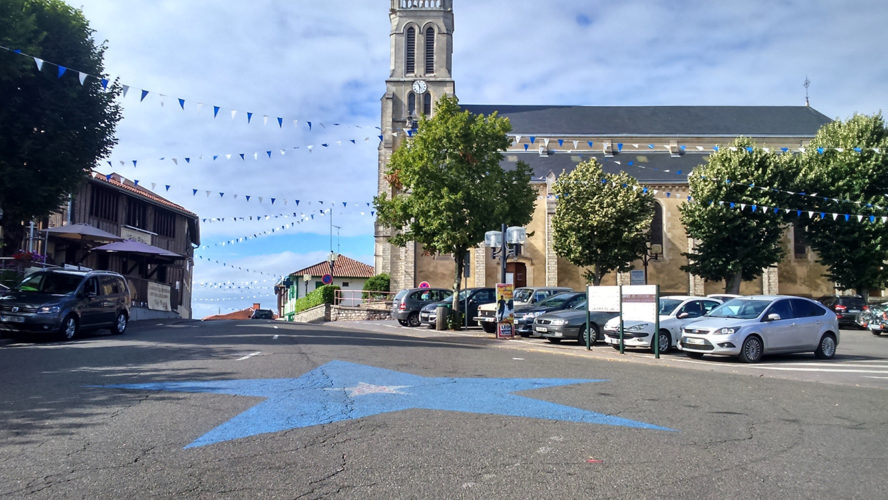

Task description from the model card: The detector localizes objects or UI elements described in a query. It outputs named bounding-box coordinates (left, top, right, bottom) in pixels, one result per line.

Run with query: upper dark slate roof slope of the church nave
left=460, top=104, right=831, bottom=137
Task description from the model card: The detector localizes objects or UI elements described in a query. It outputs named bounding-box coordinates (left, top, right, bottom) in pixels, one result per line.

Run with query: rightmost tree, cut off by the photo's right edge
left=796, top=114, right=888, bottom=296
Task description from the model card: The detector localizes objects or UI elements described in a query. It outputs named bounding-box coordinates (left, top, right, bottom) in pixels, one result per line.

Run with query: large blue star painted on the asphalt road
left=100, top=361, right=672, bottom=448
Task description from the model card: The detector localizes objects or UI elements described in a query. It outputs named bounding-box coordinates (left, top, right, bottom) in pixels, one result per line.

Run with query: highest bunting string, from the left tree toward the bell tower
left=0, top=45, right=379, bottom=132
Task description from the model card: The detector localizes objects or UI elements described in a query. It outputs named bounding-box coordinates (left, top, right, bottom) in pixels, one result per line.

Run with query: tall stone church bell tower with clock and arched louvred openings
left=374, top=0, right=455, bottom=290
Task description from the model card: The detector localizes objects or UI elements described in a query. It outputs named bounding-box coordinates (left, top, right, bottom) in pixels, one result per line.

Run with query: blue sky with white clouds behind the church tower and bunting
left=53, top=0, right=888, bottom=318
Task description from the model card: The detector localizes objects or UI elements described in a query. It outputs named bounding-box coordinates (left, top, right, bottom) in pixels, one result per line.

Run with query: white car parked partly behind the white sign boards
left=603, top=295, right=722, bottom=352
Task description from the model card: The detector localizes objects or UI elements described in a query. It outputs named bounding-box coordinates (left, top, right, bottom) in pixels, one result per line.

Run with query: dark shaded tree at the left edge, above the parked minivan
left=0, top=0, right=121, bottom=254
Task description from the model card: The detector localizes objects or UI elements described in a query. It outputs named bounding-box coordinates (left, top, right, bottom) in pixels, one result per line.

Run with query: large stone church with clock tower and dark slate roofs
left=375, top=0, right=834, bottom=297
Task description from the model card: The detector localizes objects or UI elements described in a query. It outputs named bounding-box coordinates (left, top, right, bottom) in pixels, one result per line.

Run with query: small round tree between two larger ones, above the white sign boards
left=552, top=158, right=654, bottom=286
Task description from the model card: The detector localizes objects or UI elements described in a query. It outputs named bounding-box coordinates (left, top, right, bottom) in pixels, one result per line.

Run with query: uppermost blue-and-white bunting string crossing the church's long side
left=511, top=135, right=882, bottom=157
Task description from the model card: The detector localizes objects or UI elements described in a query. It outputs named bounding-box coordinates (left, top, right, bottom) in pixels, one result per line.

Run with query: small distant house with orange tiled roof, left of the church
left=274, top=252, right=374, bottom=321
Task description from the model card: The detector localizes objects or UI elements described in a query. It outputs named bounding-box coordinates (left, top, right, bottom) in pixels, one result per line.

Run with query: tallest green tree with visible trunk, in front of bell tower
left=374, top=95, right=536, bottom=318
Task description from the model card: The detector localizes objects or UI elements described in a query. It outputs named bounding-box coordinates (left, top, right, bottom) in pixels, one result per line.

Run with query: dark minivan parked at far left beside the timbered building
left=0, top=269, right=131, bottom=340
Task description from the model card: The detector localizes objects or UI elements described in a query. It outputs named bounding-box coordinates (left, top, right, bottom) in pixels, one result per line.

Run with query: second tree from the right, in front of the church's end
left=680, top=137, right=798, bottom=293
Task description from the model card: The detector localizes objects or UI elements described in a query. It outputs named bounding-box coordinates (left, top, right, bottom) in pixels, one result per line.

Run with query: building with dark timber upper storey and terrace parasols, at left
left=38, top=172, right=200, bottom=319
